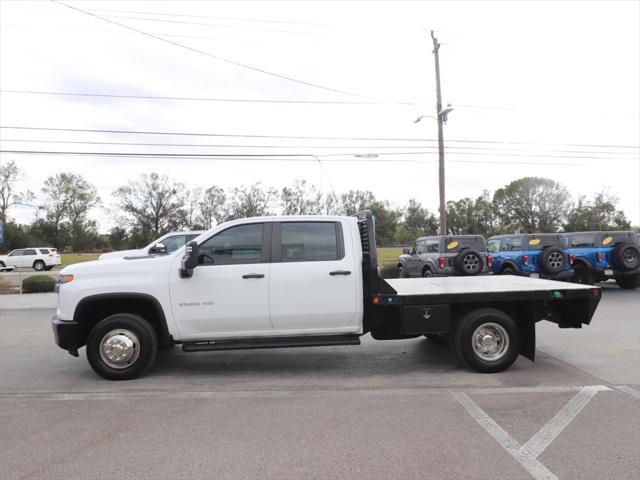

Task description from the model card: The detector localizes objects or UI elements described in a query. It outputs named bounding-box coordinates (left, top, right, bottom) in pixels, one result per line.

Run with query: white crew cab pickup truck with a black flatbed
left=52, top=211, right=600, bottom=380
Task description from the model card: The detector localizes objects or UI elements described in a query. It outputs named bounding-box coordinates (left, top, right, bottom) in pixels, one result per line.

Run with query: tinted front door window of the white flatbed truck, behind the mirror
left=198, top=223, right=264, bottom=265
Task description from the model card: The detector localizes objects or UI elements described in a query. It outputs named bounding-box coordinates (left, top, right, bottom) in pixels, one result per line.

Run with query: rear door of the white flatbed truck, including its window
left=269, top=221, right=362, bottom=333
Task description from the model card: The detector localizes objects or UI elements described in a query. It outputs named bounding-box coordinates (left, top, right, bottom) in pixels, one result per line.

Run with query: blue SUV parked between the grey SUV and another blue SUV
left=487, top=233, right=574, bottom=280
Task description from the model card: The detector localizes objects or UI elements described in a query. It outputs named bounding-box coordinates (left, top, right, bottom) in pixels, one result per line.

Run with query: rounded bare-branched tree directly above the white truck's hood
left=114, top=172, right=185, bottom=242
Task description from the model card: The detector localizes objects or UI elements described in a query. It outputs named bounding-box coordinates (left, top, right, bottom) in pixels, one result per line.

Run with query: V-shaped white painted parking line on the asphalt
left=451, top=385, right=611, bottom=480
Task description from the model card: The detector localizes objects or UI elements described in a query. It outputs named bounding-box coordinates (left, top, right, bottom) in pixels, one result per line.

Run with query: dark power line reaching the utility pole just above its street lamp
left=0, top=90, right=420, bottom=105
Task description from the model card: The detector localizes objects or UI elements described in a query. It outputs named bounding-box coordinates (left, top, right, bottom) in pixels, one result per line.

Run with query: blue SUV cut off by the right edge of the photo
left=565, top=232, right=640, bottom=289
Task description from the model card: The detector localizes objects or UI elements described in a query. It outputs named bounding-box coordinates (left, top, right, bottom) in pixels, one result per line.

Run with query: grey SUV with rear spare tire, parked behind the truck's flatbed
left=397, top=235, right=489, bottom=278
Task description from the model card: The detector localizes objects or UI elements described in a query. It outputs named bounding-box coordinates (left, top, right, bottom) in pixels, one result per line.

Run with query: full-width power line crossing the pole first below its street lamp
left=0, top=125, right=640, bottom=149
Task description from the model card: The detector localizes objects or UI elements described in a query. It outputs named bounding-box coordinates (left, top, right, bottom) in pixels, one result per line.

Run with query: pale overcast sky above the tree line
left=0, top=0, right=640, bottom=231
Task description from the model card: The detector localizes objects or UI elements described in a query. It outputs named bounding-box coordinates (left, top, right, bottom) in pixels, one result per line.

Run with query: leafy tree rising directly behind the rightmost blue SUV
left=564, top=192, right=631, bottom=232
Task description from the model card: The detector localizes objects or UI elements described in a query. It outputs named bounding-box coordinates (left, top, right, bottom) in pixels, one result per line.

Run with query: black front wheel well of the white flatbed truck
left=73, top=295, right=173, bottom=347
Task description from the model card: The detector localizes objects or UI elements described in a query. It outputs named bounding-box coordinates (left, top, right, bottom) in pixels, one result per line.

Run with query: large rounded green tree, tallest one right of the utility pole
left=493, top=177, right=571, bottom=233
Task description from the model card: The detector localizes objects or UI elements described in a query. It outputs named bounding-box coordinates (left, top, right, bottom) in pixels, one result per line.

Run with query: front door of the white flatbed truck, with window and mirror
left=171, top=223, right=271, bottom=338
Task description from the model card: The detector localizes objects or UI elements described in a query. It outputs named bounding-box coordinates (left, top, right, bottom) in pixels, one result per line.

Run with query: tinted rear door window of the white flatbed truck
left=274, top=222, right=344, bottom=262
